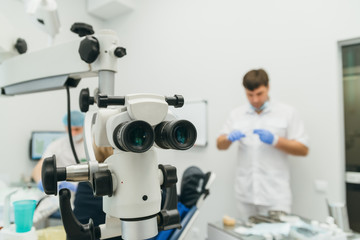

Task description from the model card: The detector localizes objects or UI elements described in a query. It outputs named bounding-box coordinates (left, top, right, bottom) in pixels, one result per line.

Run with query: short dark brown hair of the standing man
left=243, top=69, right=269, bottom=91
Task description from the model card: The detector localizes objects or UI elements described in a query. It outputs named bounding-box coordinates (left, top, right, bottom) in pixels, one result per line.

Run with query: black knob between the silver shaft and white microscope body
left=93, top=170, right=113, bottom=197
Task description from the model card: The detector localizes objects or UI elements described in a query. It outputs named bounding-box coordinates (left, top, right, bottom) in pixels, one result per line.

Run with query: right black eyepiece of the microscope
left=155, top=120, right=197, bottom=150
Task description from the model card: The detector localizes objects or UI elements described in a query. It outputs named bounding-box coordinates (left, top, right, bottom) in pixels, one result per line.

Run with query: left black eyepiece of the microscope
left=113, top=120, right=155, bottom=153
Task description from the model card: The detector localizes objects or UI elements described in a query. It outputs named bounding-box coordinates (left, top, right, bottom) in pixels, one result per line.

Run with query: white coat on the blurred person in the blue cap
left=42, top=135, right=86, bottom=167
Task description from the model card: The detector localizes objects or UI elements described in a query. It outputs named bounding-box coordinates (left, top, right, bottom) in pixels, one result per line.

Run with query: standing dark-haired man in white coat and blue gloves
left=217, top=69, right=308, bottom=221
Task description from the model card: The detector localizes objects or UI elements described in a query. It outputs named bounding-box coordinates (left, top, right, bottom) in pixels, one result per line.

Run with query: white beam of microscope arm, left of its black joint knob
left=0, top=39, right=87, bottom=95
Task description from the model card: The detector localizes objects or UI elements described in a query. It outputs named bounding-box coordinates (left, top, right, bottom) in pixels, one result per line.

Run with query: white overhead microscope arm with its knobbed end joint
left=0, top=24, right=126, bottom=95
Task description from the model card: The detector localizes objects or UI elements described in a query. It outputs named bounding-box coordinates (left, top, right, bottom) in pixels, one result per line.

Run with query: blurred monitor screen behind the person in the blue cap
left=30, top=131, right=67, bottom=160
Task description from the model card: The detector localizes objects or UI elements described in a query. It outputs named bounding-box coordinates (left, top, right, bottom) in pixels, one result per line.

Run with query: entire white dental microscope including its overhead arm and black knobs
left=0, top=23, right=197, bottom=240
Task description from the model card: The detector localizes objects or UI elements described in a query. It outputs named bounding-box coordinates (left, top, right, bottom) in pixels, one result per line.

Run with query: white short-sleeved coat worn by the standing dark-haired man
left=221, top=102, right=308, bottom=206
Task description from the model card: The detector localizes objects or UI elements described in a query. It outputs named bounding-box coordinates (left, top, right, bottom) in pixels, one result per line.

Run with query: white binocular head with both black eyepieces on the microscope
left=95, top=94, right=197, bottom=153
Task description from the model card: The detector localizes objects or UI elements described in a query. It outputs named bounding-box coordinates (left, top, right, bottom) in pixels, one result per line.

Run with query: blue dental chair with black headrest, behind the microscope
left=154, top=166, right=215, bottom=240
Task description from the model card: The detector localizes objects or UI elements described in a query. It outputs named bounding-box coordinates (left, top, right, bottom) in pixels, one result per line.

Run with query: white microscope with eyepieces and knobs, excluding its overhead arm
left=42, top=92, right=196, bottom=240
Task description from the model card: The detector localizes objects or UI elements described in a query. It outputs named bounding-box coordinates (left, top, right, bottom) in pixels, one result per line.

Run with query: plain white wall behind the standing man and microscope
left=0, top=0, right=360, bottom=239
